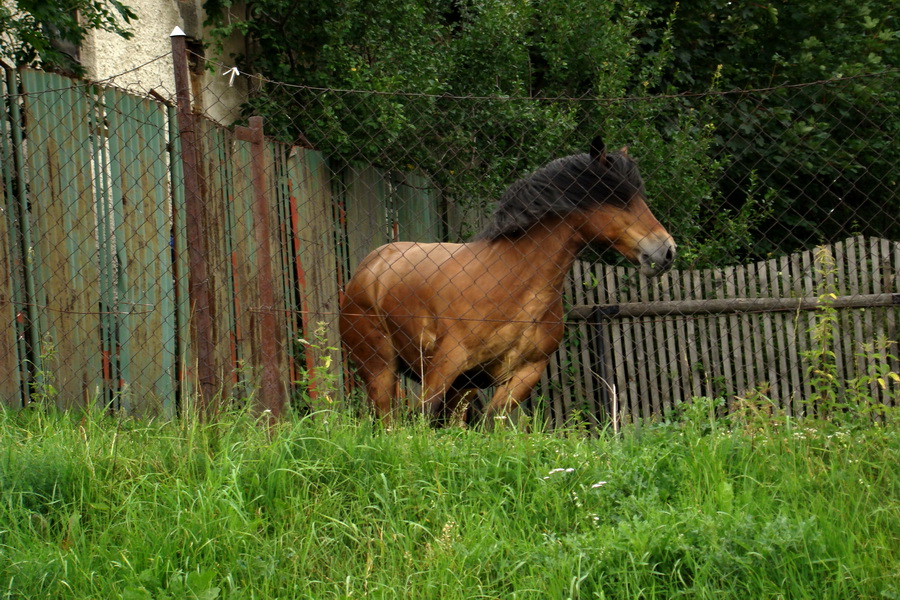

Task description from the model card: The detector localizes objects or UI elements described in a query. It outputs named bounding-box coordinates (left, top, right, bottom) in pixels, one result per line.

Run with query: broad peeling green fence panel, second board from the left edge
left=22, top=70, right=102, bottom=408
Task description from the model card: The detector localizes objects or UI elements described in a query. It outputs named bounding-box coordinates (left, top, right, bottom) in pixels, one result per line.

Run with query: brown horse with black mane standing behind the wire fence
left=340, top=138, right=675, bottom=422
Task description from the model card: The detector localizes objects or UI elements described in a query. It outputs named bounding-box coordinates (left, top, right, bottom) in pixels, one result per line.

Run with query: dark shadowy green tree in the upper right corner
left=643, top=0, right=900, bottom=255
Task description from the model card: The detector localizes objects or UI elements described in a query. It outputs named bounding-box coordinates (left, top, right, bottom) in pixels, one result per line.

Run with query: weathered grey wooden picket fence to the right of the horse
left=534, top=237, right=900, bottom=424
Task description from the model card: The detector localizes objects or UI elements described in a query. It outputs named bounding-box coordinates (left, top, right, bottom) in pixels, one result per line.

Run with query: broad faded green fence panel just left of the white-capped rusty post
left=104, top=90, right=177, bottom=416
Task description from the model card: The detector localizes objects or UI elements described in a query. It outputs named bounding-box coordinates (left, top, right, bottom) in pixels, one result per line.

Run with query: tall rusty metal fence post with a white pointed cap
left=170, top=27, right=218, bottom=418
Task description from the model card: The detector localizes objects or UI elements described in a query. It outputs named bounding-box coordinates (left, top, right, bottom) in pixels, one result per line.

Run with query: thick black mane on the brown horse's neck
left=473, top=152, right=644, bottom=241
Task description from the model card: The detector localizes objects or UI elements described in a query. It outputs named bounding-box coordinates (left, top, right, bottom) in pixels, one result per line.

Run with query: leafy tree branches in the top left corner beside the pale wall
left=0, top=0, right=137, bottom=74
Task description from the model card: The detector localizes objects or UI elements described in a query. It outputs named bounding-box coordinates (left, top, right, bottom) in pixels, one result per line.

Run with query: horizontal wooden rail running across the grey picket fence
left=568, top=294, right=900, bottom=320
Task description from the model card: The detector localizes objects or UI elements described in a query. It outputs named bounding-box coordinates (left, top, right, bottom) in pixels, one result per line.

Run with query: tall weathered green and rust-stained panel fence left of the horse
left=0, top=70, right=441, bottom=415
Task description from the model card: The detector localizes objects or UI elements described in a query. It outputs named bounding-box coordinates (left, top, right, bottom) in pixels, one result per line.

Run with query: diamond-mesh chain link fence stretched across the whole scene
left=0, top=51, right=900, bottom=426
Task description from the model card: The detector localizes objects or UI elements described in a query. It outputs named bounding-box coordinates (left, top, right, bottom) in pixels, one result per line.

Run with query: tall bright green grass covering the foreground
left=0, top=410, right=900, bottom=600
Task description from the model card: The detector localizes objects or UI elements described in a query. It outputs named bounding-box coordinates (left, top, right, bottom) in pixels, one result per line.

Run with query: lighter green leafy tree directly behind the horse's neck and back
left=205, top=0, right=710, bottom=258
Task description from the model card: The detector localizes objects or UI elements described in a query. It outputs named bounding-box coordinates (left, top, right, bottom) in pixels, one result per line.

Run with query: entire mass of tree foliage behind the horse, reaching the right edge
left=205, top=0, right=900, bottom=265
